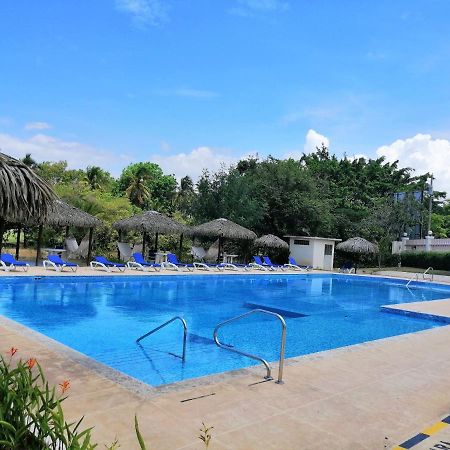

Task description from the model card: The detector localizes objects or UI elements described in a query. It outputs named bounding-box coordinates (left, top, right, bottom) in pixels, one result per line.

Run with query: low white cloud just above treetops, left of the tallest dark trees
left=150, top=147, right=241, bottom=180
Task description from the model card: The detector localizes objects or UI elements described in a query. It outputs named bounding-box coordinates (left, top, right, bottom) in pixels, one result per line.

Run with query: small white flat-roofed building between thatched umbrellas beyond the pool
left=284, top=236, right=341, bottom=270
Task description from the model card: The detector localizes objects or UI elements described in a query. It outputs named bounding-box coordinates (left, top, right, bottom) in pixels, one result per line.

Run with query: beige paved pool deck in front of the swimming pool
left=0, top=268, right=450, bottom=450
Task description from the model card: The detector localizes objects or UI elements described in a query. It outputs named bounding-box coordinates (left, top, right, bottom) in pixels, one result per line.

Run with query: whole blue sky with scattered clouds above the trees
left=0, top=0, right=450, bottom=192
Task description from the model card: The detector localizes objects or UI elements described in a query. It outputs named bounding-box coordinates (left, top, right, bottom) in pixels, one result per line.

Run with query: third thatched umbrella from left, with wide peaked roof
left=113, top=211, right=189, bottom=253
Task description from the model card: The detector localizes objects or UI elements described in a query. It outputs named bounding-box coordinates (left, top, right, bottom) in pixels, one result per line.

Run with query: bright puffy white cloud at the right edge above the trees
left=377, top=133, right=450, bottom=192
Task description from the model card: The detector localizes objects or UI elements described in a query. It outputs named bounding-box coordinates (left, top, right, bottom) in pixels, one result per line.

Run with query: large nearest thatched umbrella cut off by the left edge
left=0, top=153, right=57, bottom=251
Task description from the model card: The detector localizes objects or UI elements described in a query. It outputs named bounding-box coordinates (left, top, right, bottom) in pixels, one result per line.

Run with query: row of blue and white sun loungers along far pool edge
left=0, top=252, right=310, bottom=272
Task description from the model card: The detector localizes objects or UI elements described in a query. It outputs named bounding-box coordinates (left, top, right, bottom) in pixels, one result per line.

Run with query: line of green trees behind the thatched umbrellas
left=18, top=145, right=450, bottom=262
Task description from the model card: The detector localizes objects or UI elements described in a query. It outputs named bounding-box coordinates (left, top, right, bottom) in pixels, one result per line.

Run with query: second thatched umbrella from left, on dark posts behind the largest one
left=22, top=199, right=101, bottom=265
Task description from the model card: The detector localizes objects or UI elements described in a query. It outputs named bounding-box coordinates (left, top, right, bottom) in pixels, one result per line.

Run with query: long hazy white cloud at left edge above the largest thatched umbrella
left=0, top=133, right=131, bottom=175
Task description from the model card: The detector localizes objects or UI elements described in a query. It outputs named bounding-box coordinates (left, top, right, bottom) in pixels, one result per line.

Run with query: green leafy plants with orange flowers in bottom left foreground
left=0, top=347, right=213, bottom=450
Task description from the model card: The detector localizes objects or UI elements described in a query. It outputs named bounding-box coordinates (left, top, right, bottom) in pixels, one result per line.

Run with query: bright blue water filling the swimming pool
left=0, top=274, right=450, bottom=385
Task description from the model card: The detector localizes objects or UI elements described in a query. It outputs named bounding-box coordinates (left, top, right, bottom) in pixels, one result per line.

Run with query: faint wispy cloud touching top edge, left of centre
left=116, top=0, right=168, bottom=27
